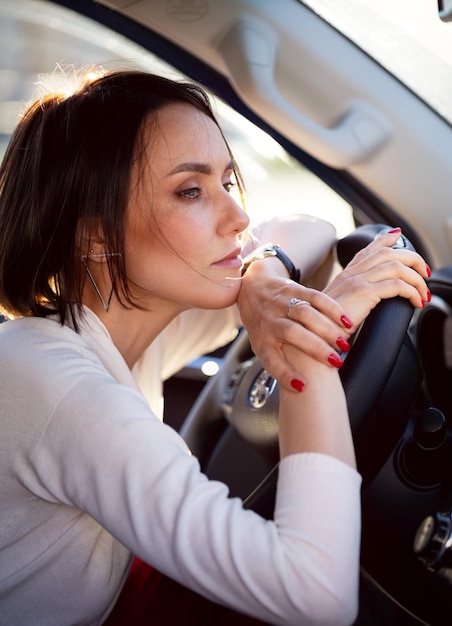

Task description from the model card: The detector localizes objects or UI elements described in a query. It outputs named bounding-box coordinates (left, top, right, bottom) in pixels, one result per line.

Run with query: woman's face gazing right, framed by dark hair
left=126, top=103, right=249, bottom=308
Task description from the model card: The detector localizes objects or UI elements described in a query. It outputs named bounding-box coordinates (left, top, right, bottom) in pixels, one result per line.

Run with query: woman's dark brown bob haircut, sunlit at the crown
left=0, top=70, right=243, bottom=330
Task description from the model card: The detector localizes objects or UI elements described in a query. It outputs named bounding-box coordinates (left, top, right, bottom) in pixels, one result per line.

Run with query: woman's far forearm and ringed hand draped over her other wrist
left=238, top=215, right=358, bottom=389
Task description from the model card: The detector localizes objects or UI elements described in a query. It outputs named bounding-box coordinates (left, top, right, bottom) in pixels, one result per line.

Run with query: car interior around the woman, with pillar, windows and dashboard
left=0, top=0, right=452, bottom=626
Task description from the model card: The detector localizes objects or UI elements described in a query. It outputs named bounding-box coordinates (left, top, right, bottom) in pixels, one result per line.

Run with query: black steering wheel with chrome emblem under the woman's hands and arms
left=180, top=224, right=413, bottom=517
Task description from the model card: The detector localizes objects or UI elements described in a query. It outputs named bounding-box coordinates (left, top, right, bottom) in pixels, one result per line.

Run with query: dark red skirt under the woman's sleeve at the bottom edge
left=104, top=558, right=267, bottom=626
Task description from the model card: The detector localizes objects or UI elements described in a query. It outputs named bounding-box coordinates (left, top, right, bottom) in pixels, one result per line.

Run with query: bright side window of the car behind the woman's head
left=0, top=0, right=354, bottom=236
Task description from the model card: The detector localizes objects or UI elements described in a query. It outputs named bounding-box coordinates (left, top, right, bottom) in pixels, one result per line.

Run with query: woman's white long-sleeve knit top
left=0, top=311, right=361, bottom=626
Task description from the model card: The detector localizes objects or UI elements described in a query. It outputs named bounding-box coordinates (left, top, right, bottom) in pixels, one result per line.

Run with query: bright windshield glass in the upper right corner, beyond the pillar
left=303, top=0, right=452, bottom=123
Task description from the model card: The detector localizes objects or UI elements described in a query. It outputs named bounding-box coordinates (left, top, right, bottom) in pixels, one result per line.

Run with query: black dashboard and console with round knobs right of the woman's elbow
left=348, top=245, right=452, bottom=626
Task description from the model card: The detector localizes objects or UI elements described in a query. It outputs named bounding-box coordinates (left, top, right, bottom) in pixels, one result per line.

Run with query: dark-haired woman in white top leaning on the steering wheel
left=0, top=72, right=428, bottom=626
